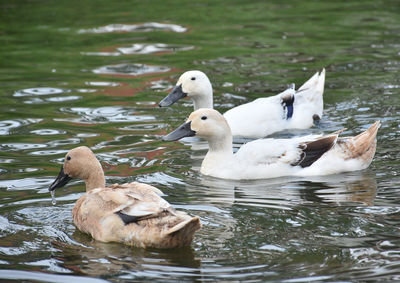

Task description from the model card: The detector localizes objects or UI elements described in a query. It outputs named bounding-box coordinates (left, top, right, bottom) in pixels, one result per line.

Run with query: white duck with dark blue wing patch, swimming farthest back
left=159, top=69, right=325, bottom=138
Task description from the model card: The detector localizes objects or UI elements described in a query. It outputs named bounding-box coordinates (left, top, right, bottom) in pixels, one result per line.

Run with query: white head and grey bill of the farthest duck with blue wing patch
left=158, top=71, right=213, bottom=110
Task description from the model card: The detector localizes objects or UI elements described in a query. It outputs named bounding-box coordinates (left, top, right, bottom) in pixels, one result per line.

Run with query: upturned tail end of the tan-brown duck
left=165, top=216, right=201, bottom=246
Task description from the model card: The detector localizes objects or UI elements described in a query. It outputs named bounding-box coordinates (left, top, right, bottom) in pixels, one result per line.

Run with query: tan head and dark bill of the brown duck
left=49, top=146, right=105, bottom=191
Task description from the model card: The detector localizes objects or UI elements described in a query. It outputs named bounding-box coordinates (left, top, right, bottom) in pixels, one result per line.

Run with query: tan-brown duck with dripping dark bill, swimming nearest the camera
left=49, top=146, right=201, bottom=248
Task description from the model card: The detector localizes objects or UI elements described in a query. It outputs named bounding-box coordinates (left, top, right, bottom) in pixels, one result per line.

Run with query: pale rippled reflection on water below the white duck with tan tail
left=201, top=172, right=377, bottom=209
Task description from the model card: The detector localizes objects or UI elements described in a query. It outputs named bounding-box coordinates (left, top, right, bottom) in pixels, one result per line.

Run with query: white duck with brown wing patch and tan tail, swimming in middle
left=163, top=108, right=380, bottom=180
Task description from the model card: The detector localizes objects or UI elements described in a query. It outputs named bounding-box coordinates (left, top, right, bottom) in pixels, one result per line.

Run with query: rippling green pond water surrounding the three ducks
left=0, top=0, right=400, bottom=282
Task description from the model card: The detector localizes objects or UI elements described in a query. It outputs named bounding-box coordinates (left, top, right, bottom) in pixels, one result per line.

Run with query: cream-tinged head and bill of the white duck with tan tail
left=163, top=108, right=232, bottom=142
